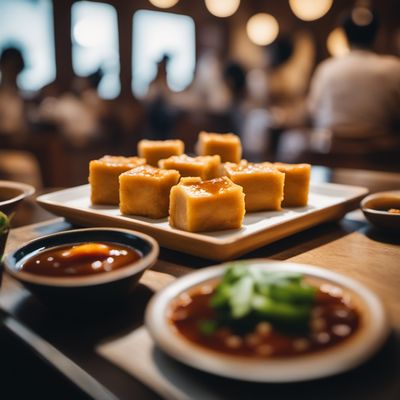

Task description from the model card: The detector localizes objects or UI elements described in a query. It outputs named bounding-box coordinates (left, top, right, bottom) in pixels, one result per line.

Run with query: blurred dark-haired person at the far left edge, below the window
left=0, top=47, right=26, bottom=139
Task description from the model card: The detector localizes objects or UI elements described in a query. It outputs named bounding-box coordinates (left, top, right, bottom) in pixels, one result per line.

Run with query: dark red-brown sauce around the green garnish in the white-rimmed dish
left=169, top=284, right=360, bottom=358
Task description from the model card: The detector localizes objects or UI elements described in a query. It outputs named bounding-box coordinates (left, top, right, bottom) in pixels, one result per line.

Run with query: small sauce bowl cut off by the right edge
left=361, top=190, right=400, bottom=231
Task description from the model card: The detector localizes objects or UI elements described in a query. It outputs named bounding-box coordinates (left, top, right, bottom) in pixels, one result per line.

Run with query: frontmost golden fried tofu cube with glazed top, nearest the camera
left=169, top=176, right=245, bottom=232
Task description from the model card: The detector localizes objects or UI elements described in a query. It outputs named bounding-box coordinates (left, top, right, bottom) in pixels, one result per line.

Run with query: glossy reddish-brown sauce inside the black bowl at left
left=20, top=242, right=142, bottom=277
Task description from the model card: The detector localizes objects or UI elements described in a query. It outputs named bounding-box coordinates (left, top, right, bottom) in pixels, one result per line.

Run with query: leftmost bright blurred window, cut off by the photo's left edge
left=0, top=0, right=56, bottom=91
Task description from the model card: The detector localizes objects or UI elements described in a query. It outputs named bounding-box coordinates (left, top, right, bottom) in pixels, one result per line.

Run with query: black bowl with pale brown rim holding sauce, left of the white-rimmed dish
left=4, top=228, right=159, bottom=308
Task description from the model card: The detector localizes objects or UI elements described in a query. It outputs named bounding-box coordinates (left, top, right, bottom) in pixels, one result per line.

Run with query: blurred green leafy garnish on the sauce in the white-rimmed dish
left=206, top=263, right=316, bottom=331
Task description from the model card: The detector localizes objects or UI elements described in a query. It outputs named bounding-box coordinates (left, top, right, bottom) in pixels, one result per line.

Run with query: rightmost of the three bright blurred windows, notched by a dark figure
left=132, top=10, right=196, bottom=97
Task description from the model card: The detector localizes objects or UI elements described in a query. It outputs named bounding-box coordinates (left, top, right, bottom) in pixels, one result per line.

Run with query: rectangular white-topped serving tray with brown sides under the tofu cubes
left=37, top=183, right=368, bottom=260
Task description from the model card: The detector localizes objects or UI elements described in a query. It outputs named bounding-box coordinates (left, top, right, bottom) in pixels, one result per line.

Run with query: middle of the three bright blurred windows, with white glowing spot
left=71, top=1, right=121, bottom=99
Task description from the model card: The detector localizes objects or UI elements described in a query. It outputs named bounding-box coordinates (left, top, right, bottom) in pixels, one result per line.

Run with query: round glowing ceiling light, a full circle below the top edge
left=246, top=13, right=279, bottom=46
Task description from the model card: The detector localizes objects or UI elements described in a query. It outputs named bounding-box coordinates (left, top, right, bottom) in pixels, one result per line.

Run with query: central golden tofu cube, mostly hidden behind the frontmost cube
left=158, top=154, right=222, bottom=180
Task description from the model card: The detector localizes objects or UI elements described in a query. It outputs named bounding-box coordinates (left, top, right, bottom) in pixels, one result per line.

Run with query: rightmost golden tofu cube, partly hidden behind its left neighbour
left=274, top=163, right=311, bottom=207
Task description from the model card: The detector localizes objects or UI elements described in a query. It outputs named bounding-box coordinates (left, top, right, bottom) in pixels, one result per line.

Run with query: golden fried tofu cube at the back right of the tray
left=197, top=132, right=242, bottom=163
